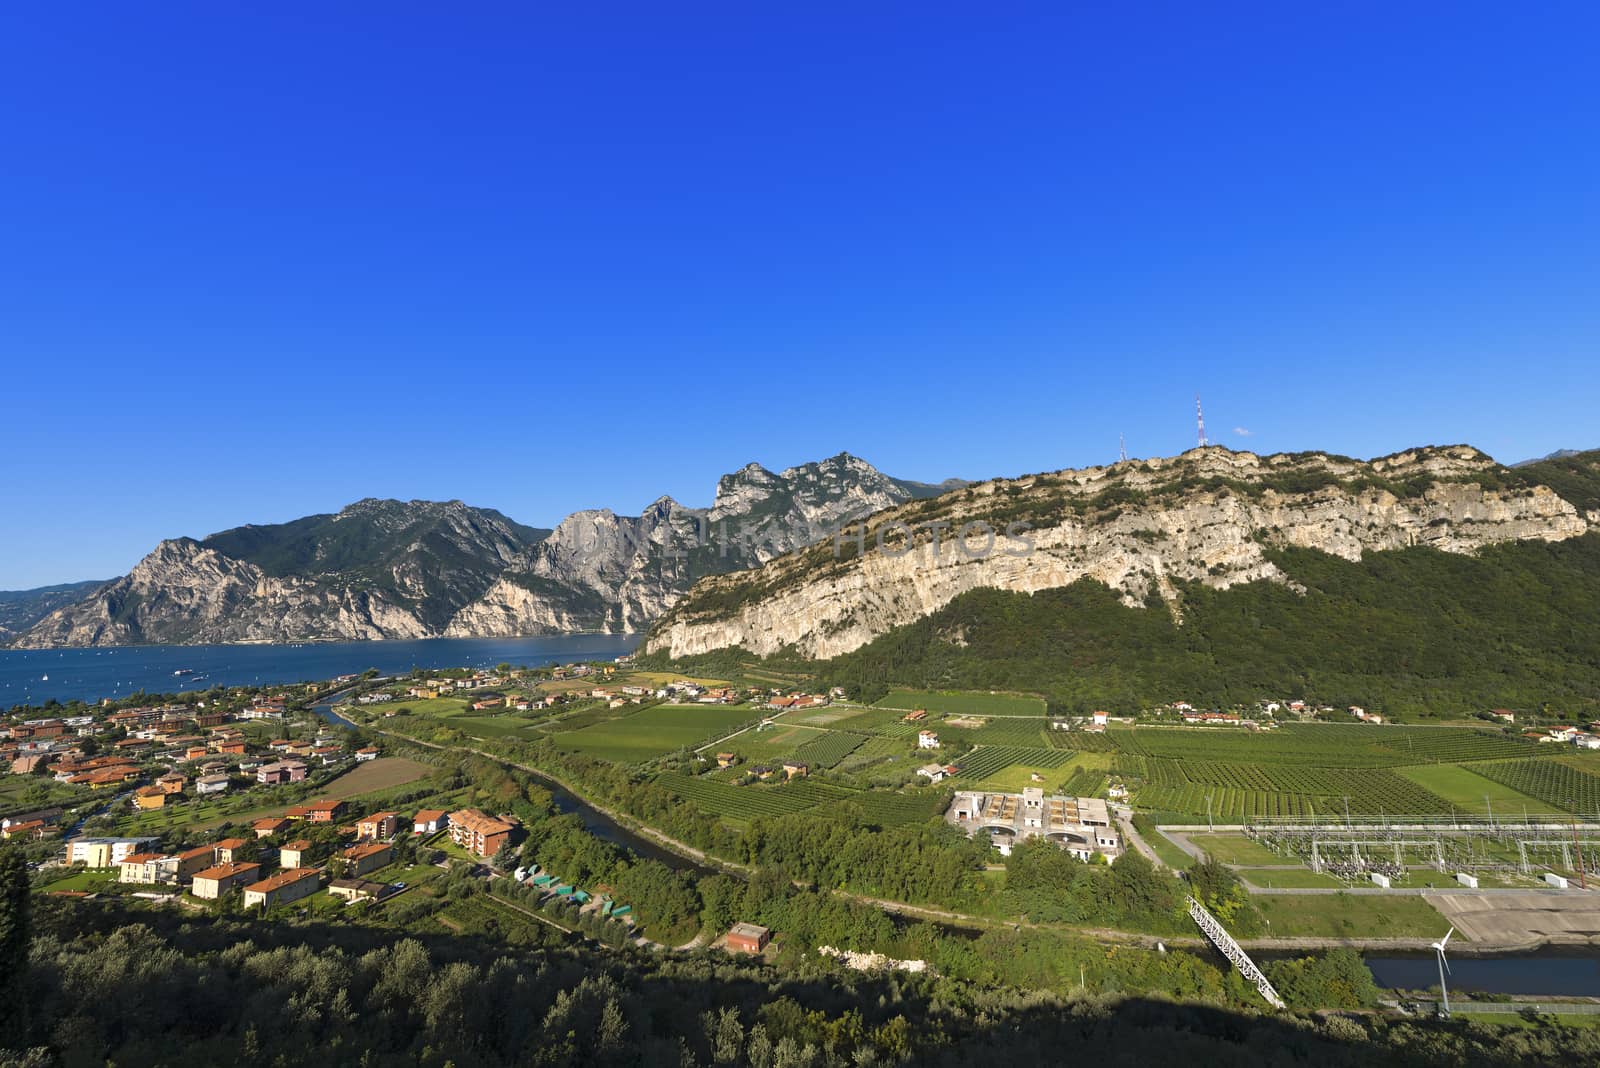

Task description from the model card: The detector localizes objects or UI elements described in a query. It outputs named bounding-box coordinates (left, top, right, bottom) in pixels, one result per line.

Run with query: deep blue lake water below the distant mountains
left=0, top=635, right=640, bottom=708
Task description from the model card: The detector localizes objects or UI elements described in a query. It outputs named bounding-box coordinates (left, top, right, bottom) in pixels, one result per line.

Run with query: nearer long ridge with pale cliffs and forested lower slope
left=642, top=446, right=1600, bottom=723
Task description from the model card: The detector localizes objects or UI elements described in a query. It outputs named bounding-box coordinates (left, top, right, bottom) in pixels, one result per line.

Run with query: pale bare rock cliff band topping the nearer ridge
left=646, top=446, right=1592, bottom=657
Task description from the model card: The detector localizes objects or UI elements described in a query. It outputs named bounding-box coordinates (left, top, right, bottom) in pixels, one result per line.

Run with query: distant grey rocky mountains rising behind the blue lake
left=0, top=452, right=965, bottom=648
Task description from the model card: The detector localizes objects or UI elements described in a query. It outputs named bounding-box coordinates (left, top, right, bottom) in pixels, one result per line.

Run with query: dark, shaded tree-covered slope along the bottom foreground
left=0, top=862, right=1600, bottom=1068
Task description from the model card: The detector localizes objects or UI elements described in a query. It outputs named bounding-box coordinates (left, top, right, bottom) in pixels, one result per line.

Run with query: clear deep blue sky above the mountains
left=0, top=2, right=1600, bottom=588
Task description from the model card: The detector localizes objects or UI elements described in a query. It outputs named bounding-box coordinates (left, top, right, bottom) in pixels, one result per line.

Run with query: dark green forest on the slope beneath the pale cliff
left=664, top=532, right=1600, bottom=718
